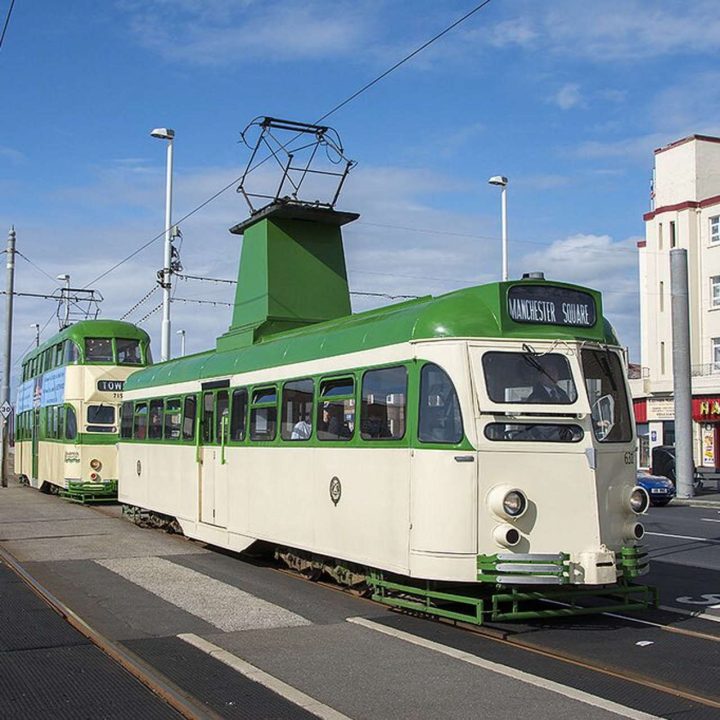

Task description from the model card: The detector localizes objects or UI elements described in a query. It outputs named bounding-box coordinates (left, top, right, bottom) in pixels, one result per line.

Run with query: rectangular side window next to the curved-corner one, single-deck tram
left=360, top=367, right=407, bottom=440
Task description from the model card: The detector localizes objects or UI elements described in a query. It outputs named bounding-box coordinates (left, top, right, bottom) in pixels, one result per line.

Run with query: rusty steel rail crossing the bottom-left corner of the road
left=0, top=547, right=222, bottom=720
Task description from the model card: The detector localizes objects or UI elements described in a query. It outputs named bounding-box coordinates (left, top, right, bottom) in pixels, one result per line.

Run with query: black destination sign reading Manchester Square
left=507, top=285, right=597, bottom=328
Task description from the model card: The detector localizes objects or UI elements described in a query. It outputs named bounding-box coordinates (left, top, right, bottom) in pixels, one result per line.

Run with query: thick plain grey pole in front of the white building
left=670, top=248, right=695, bottom=498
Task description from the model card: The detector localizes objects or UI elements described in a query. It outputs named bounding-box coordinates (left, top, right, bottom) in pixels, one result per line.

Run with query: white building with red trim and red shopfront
left=631, top=135, right=720, bottom=468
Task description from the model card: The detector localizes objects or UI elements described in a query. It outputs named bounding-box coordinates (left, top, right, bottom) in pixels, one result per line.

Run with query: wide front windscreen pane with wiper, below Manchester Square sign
left=482, top=351, right=577, bottom=405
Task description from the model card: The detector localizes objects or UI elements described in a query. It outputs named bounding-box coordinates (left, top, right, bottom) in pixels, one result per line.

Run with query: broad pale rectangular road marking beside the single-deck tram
left=95, top=557, right=310, bottom=632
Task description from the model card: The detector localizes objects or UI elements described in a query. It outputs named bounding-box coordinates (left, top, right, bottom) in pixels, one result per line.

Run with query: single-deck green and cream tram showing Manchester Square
left=119, top=203, right=653, bottom=622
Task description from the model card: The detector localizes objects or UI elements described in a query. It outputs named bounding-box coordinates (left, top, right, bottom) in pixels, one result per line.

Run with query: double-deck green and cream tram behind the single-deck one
left=15, top=320, right=150, bottom=501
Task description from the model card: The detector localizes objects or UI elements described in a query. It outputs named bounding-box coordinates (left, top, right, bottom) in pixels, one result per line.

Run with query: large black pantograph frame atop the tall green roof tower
left=237, top=117, right=357, bottom=215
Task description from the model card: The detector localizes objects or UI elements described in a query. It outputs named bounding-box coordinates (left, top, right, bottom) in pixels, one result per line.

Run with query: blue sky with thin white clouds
left=0, top=0, right=720, bottom=386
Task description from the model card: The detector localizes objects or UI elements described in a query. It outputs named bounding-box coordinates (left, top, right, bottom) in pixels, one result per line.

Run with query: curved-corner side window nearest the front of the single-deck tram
left=418, top=363, right=463, bottom=443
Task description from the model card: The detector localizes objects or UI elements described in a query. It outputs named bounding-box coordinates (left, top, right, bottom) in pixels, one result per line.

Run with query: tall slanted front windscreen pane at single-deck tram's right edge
left=581, top=350, right=632, bottom=442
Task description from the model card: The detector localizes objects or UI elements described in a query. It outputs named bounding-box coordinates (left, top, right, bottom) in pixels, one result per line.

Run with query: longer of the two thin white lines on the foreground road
left=348, top=617, right=659, bottom=720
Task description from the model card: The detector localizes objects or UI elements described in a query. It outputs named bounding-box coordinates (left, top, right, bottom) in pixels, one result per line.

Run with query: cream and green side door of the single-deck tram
left=199, top=390, right=228, bottom=527
